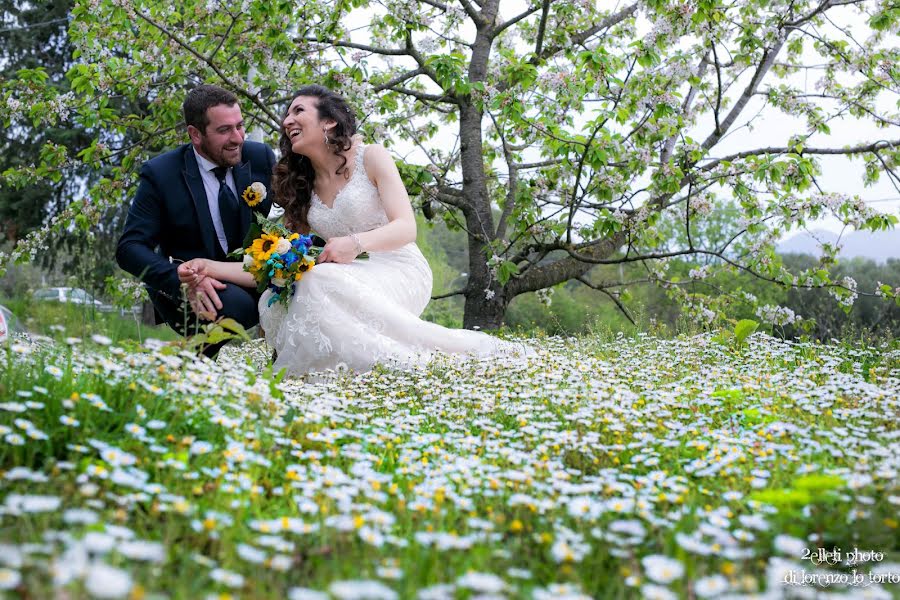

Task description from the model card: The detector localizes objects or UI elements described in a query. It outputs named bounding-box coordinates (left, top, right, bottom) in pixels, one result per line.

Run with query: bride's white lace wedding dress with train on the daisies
left=259, top=145, right=522, bottom=375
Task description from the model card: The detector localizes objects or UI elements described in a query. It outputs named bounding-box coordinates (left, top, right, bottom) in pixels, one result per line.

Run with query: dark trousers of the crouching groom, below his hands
left=149, top=283, right=259, bottom=358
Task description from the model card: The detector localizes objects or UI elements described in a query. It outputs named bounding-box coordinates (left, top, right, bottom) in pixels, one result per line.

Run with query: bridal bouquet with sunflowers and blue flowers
left=232, top=214, right=321, bottom=306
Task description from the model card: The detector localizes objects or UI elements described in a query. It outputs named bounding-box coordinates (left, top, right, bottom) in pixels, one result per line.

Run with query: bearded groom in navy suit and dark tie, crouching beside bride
left=116, top=85, right=275, bottom=357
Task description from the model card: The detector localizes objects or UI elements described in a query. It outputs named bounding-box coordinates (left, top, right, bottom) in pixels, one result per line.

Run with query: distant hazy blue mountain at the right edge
left=776, top=229, right=900, bottom=263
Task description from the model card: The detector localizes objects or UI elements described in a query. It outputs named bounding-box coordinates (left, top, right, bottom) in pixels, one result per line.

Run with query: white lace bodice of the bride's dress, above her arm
left=307, top=144, right=388, bottom=240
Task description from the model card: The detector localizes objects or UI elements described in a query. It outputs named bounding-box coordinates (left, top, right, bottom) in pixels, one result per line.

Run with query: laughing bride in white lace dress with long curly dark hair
left=178, top=85, right=519, bottom=375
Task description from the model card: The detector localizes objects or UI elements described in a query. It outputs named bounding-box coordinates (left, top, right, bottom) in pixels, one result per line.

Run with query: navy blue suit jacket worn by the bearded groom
left=116, top=142, right=275, bottom=299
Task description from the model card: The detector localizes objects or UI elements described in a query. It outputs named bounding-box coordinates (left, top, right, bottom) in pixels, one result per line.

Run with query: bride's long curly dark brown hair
left=272, top=85, right=356, bottom=233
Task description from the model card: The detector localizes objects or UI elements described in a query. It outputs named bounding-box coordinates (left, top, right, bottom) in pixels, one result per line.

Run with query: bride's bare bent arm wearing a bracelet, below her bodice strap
left=319, top=144, right=416, bottom=262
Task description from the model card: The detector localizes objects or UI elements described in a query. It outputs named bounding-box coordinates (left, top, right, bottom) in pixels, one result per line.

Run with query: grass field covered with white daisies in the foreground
left=0, top=334, right=900, bottom=600
